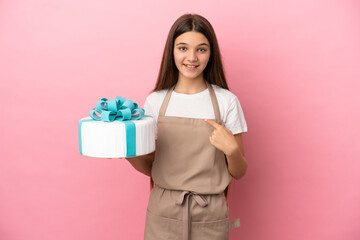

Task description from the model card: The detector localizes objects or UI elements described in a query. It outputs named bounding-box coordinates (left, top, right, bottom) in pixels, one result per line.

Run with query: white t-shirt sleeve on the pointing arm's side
left=225, top=97, right=247, bottom=135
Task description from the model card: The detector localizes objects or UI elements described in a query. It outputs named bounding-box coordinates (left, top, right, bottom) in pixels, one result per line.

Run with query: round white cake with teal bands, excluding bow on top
left=79, top=116, right=155, bottom=158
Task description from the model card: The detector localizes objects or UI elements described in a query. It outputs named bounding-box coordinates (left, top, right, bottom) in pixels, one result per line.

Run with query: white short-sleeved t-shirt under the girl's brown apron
left=144, top=84, right=247, bottom=139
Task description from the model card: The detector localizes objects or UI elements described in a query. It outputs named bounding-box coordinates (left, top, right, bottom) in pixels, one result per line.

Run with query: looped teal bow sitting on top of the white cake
left=90, top=96, right=145, bottom=122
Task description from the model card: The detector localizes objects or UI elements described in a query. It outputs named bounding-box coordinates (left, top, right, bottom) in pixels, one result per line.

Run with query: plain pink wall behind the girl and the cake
left=0, top=0, right=360, bottom=240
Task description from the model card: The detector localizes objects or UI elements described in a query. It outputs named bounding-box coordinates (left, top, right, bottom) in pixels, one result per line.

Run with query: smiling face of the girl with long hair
left=174, top=31, right=210, bottom=79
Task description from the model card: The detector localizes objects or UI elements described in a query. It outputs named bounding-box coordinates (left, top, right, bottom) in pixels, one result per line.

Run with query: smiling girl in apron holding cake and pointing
left=128, top=14, right=247, bottom=240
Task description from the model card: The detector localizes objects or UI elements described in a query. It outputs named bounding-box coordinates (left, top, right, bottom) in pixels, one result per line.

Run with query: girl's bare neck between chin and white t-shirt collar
left=174, top=77, right=207, bottom=94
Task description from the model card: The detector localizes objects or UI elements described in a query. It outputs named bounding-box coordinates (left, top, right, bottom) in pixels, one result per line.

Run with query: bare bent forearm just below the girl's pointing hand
left=226, top=147, right=247, bottom=179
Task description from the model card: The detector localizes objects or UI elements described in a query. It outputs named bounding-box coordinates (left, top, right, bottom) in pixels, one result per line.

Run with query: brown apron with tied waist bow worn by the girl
left=144, top=82, right=240, bottom=240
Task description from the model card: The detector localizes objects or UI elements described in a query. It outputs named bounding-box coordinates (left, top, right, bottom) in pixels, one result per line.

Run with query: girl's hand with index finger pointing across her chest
left=205, top=119, right=238, bottom=156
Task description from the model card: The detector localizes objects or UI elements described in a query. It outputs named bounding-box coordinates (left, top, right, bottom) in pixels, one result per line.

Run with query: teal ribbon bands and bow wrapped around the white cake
left=78, top=96, right=146, bottom=157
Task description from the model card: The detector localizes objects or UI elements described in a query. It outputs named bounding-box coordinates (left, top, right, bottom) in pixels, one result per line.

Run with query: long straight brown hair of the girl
left=153, top=14, right=229, bottom=91
